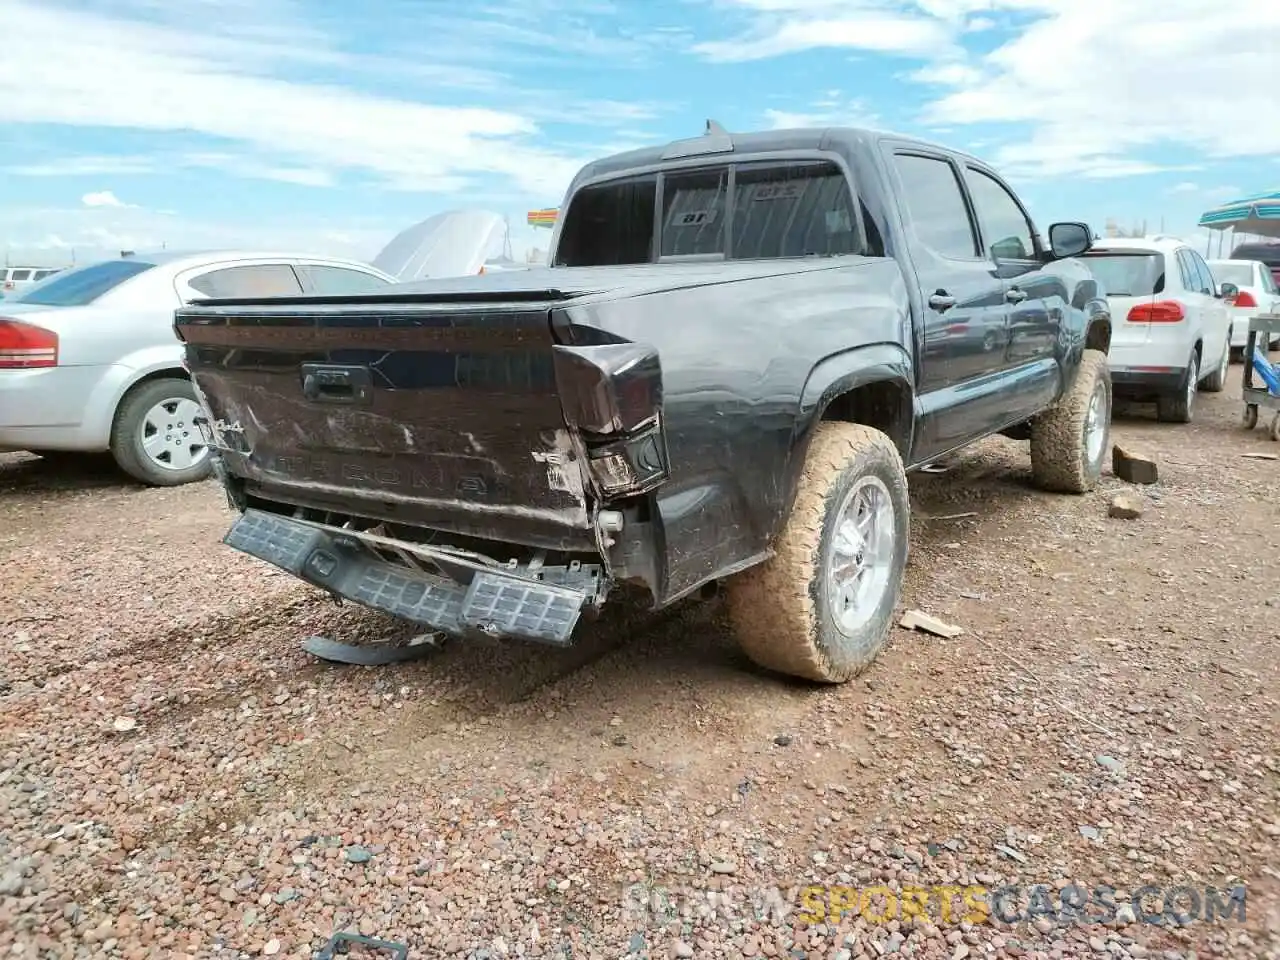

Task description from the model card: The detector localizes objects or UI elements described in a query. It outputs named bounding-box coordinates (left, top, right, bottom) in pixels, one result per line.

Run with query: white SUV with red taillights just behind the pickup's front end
left=1082, top=237, right=1231, bottom=424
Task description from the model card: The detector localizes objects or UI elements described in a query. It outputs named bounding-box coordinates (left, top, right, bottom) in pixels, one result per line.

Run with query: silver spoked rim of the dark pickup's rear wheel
left=826, top=476, right=896, bottom=636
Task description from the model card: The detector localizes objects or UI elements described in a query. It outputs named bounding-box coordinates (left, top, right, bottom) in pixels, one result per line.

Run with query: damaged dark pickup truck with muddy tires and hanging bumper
left=175, top=123, right=1111, bottom=682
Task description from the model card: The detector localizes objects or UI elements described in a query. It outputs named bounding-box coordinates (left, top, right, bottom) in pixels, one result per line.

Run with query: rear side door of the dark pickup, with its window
left=884, top=149, right=1009, bottom=461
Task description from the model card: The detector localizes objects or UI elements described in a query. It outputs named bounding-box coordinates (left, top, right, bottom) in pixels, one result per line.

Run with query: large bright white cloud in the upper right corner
left=922, top=0, right=1280, bottom=177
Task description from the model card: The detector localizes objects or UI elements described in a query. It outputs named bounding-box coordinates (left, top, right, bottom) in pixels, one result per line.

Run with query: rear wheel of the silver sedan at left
left=111, top=378, right=212, bottom=486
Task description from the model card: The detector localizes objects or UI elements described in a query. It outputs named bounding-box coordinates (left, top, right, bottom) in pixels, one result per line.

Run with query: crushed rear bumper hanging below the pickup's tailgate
left=223, top=509, right=607, bottom=646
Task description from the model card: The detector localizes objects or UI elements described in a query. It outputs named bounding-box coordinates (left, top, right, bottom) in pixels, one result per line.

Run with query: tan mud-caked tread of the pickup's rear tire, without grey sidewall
left=726, top=421, right=906, bottom=684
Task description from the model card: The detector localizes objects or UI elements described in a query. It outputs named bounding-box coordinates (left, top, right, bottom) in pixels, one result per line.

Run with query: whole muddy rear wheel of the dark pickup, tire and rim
left=726, top=422, right=911, bottom=684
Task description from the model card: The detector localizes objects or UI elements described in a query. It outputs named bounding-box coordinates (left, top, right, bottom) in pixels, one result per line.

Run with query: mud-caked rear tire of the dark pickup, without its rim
left=726, top=422, right=911, bottom=684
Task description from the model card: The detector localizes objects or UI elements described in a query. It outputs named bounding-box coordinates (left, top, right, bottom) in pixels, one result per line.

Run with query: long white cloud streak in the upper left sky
left=0, top=0, right=585, bottom=195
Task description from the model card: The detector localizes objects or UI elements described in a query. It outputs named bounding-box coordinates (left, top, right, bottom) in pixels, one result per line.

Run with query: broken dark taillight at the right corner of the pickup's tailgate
left=556, top=343, right=669, bottom=499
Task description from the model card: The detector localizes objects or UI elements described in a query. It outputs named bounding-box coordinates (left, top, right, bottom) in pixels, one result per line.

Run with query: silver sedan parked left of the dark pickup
left=0, top=251, right=393, bottom=485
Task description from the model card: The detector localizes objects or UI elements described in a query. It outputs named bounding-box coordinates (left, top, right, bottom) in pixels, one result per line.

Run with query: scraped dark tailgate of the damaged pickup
left=175, top=294, right=590, bottom=529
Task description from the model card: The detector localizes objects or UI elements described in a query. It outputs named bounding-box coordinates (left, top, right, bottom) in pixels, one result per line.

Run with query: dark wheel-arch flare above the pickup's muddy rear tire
left=772, top=343, right=915, bottom=532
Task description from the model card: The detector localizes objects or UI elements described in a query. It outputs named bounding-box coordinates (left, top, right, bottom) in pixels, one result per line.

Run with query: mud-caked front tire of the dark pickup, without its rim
left=1030, top=349, right=1112, bottom=493
